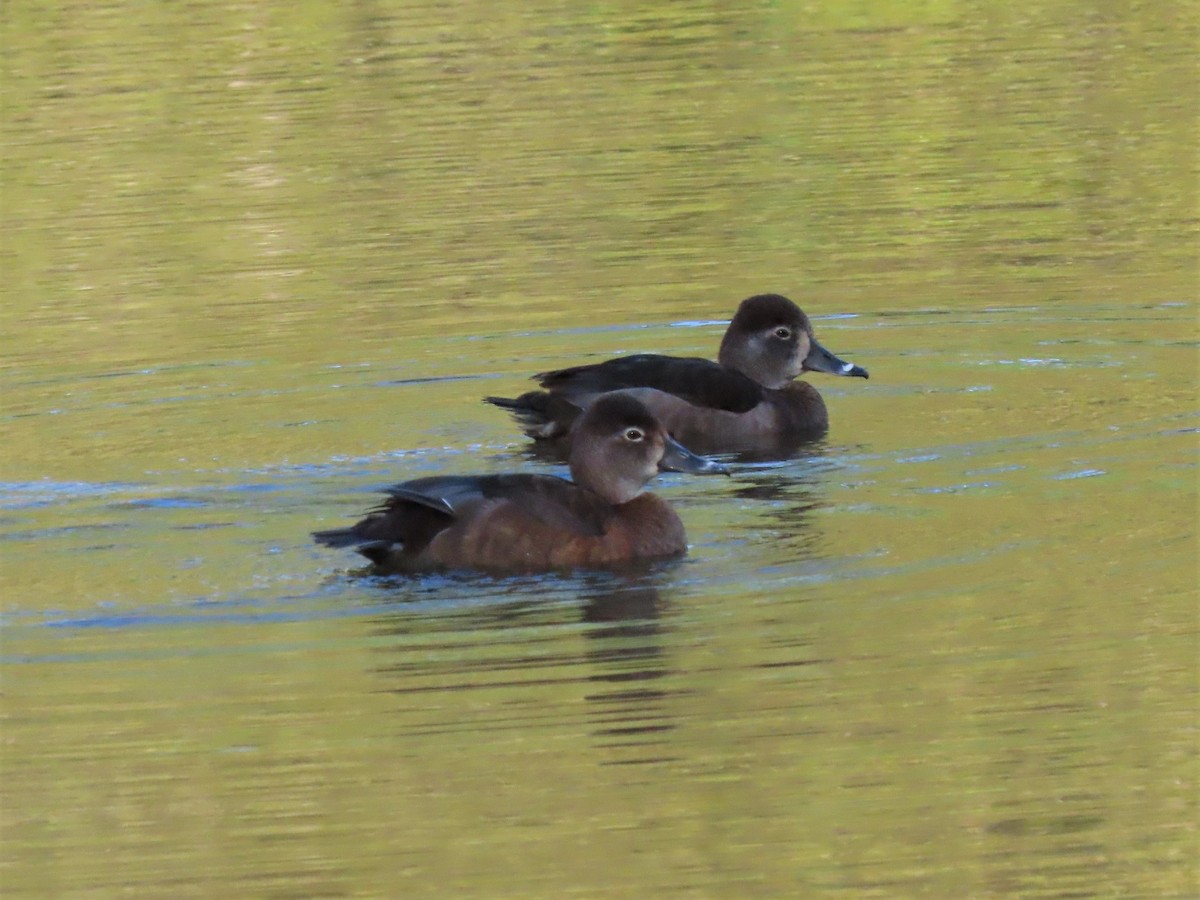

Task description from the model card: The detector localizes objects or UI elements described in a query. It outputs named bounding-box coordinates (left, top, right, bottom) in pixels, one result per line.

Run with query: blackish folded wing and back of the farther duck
left=534, top=353, right=764, bottom=413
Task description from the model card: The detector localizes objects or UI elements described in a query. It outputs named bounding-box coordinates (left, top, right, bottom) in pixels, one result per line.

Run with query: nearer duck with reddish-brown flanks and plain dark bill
left=312, top=394, right=728, bottom=572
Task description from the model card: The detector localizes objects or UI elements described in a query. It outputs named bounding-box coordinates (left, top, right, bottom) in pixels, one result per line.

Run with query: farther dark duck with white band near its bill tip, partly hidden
left=484, top=294, right=869, bottom=458
